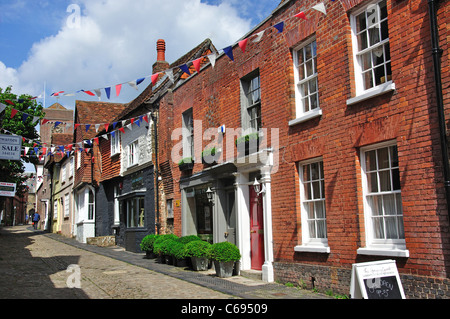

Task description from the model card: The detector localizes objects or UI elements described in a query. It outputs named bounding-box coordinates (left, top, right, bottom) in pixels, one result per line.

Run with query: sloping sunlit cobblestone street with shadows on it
left=0, top=226, right=329, bottom=300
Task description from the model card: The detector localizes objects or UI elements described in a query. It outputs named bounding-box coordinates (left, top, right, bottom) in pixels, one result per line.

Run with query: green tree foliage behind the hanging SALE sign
left=0, top=86, right=45, bottom=196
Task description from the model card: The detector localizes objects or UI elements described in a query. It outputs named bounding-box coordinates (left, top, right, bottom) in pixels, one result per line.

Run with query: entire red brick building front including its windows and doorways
left=158, top=0, right=450, bottom=298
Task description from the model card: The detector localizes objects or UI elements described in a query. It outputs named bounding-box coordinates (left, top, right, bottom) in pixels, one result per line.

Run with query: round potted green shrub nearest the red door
left=210, top=241, right=241, bottom=278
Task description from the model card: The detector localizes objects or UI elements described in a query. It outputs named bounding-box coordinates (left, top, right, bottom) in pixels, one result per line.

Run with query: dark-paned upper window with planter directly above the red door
left=241, top=72, right=261, bottom=132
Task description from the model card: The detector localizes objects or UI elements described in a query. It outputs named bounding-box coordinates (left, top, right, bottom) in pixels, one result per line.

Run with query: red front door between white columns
left=249, top=186, right=264, bottom=270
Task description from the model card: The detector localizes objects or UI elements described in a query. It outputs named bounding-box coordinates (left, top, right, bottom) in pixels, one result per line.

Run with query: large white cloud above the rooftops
left=0, top=0, right=251, bottom=106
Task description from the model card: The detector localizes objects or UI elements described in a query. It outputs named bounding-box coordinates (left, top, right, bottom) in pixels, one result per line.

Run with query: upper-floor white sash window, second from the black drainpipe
left=293, top=39, right=319, bottom=118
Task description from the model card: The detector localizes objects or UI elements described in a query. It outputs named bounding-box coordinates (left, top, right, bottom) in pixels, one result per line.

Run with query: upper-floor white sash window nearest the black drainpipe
left=351, top=0, right=392, bottom=95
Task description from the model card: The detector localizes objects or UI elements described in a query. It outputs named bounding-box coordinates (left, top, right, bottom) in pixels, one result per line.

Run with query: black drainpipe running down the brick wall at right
left=428, top=0, right=450, bottom=219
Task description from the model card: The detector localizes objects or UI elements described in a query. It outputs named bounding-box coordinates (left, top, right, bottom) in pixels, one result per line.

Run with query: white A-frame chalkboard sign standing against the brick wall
left=350, top=260, right=405, bottom=299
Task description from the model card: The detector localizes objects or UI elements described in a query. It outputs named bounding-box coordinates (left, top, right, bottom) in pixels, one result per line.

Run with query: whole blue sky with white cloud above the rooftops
left=0, top=0, right=280, bottom=108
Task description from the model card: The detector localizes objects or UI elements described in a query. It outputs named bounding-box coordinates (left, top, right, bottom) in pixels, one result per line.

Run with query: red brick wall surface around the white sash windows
left=156, top=0, right=450, bottom=298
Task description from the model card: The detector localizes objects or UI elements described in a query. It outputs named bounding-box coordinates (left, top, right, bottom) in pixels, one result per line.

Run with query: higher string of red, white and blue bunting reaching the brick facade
left=51, top=0, right=326, bottom=100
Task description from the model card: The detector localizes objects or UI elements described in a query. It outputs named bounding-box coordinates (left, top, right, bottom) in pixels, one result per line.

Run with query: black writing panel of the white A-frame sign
left=364, top=276, right=402, bottom=299
